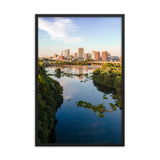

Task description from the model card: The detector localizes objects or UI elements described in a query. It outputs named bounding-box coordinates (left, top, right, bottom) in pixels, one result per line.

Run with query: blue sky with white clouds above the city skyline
left=38, top=17, right=121, bottom=56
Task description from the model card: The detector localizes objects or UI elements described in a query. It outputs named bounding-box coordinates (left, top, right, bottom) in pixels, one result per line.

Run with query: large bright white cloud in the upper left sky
left=38, top=18, right=82, bottom=43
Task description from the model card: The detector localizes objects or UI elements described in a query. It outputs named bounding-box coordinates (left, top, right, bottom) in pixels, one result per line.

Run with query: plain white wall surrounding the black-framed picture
left=0, top=0, right=160, bottom=160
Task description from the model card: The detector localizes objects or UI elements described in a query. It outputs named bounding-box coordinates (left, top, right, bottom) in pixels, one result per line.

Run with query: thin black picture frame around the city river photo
left=35, top=14, right=125, bottom=146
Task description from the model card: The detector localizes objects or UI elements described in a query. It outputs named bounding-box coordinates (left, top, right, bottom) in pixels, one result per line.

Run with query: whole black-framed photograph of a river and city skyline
left=35, top=14, right=125, bottom=146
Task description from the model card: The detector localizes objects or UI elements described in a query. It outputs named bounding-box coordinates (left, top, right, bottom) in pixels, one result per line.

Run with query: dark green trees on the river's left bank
left=38, top=65, right=63, bottom=143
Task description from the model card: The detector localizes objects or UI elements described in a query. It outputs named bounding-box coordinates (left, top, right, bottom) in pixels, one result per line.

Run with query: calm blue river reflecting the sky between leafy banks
left=46, top=66, right=122, bottom=145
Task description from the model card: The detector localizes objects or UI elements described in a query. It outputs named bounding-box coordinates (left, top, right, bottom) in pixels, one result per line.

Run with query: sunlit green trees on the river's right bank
left=92, top=63, right=122, bottom=110
